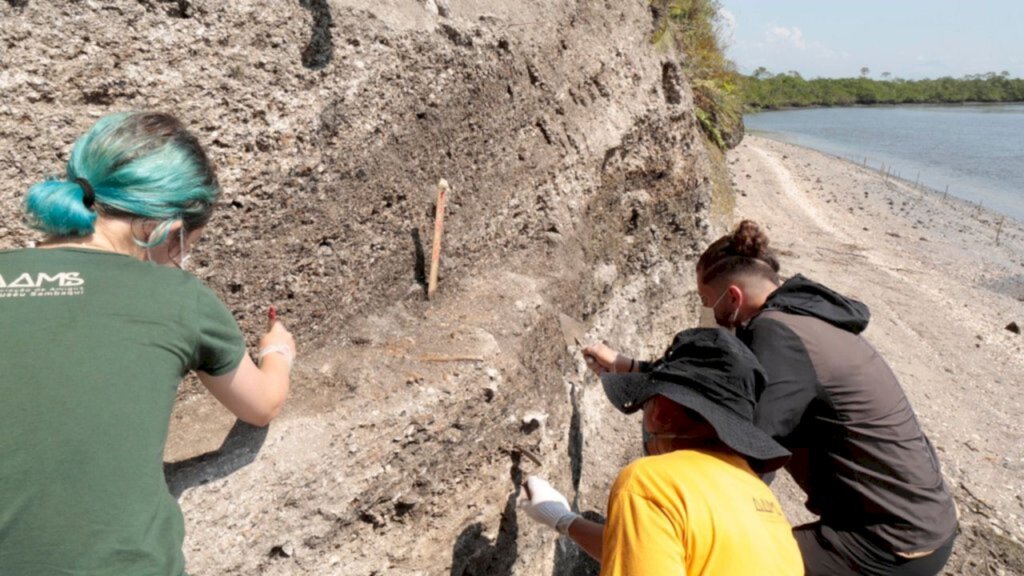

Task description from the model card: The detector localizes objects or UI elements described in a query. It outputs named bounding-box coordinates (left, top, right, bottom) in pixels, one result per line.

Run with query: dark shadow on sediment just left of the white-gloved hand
left=449, top=453, right=522, bottom=576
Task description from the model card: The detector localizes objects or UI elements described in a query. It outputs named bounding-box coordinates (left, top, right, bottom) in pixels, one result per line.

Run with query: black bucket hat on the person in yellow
left=601, top=328, right=790, bottom=474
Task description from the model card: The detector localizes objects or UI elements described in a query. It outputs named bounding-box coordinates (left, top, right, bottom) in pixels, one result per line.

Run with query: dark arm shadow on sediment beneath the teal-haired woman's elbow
left=164, top=420, right=269, bottom=499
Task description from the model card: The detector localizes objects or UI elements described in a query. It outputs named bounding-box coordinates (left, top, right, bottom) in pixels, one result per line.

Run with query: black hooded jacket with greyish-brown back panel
left=736, top=275, right=956, bottom=552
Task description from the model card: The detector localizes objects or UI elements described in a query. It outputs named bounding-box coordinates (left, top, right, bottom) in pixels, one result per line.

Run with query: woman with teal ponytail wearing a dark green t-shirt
left=0, top=113, right=295, bottom=576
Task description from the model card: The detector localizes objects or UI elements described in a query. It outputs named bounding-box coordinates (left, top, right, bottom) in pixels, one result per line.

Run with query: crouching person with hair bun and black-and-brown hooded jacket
left=696, top=220, right=956, bottom=575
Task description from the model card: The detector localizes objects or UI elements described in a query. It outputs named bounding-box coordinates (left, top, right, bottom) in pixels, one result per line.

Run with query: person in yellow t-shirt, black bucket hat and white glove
left=520, top=328, right=804, bottom=576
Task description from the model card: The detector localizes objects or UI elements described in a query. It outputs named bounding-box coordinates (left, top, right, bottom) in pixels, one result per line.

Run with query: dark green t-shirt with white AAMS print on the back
left=0, top=248, right=246, bottom=576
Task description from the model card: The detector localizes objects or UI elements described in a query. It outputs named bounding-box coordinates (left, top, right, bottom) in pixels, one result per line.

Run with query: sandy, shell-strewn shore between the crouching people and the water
left=728, top=136, right=1024, bottom=574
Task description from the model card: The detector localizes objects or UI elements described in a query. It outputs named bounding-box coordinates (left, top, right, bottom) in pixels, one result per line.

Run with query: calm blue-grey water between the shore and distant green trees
left=743, top=105, right=1024, bottom=222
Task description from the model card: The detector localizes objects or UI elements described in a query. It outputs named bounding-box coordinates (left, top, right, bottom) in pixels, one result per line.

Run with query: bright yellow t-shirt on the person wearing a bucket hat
left=601, top=450, right=804, bottom=576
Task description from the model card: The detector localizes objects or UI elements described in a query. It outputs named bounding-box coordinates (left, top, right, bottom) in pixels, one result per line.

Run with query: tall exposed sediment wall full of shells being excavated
left=0, top=0, right=711, bottom=576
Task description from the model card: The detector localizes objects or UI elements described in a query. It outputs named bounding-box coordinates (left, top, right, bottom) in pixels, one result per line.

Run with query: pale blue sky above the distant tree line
left=720, top=0, right=1024, bottom=80
